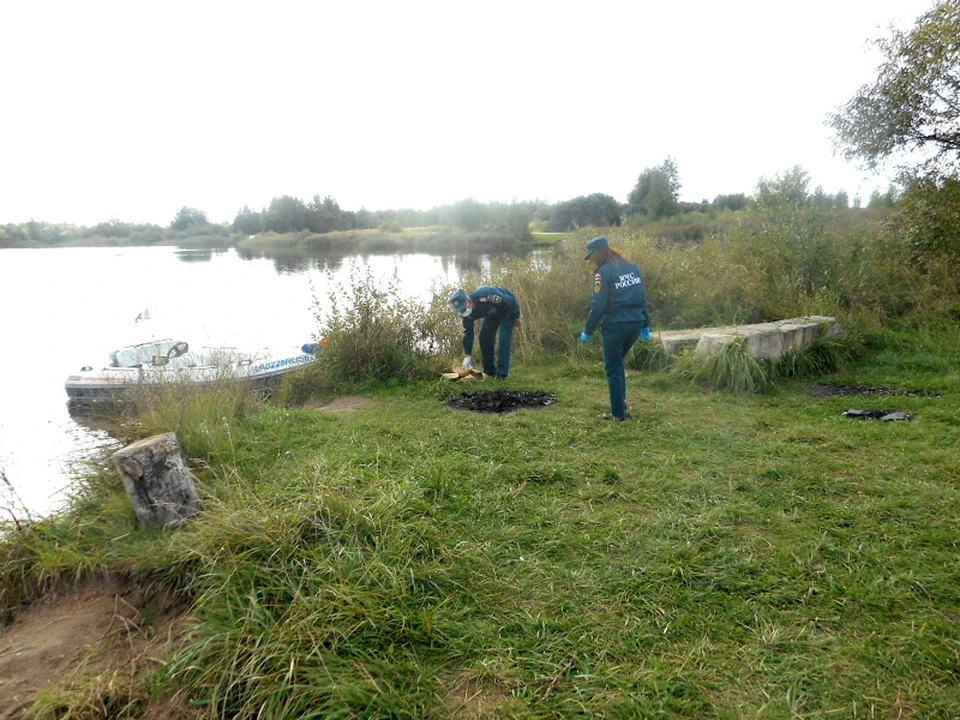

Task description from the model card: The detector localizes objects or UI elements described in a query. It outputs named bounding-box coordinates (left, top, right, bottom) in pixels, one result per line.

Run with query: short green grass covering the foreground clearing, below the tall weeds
left=3, top=326, right=960, bottom=719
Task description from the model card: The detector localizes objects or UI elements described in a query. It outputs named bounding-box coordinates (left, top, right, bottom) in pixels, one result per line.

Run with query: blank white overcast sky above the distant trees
left=0, top=0, right=935, bottom=226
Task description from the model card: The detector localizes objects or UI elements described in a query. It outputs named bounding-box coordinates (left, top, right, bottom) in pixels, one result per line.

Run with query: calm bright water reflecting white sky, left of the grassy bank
left=0, top=247, right=480, bottom=519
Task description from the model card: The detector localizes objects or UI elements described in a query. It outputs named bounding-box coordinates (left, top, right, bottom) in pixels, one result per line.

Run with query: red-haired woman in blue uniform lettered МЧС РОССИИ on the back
left=580, top=236, right=650, bottom=420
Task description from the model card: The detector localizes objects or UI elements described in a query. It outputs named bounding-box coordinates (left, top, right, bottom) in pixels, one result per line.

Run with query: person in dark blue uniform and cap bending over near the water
left=450, top=285, right=521, bottom=380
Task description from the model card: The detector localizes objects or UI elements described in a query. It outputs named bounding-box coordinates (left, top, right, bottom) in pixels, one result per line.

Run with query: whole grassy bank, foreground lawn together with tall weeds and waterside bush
left=0, top=212, right=960, bottom=720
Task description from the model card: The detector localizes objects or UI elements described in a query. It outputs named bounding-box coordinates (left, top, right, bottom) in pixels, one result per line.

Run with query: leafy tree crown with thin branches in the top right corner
left=827, top=0, right=960, bottom=174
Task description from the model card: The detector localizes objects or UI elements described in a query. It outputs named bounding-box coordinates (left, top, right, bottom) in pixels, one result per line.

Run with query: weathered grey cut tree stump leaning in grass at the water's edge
left=113, top=433, right=200, bottom=528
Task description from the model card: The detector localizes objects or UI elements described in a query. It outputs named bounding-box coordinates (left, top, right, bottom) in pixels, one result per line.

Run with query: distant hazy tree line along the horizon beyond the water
left=0, top=169, right=896, bottom=248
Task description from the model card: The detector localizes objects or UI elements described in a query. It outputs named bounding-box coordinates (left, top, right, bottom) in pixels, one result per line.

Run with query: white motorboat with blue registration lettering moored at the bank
left=64, top=339, right=320, bottom=400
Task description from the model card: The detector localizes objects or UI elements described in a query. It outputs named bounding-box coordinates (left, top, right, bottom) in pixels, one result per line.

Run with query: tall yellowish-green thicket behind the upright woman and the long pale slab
left=492, top=208, right=960, bottom=348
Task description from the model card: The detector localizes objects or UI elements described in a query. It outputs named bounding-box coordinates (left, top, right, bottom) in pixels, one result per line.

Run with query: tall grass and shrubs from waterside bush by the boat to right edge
left=292, top=208, right=958, bottom=398
